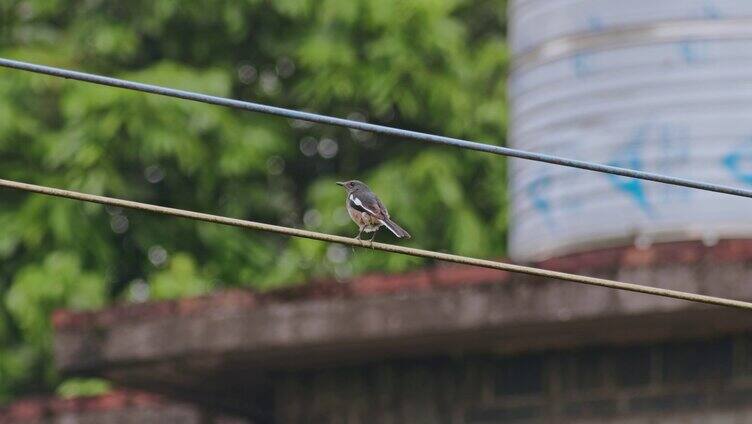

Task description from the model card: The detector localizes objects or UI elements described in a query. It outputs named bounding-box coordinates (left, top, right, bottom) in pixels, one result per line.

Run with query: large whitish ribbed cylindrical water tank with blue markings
left=509, top=0, right=752, bottom=261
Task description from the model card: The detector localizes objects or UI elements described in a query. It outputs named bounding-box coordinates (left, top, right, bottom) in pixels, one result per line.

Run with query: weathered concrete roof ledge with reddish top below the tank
left=55, top=241, right=752, bottom=407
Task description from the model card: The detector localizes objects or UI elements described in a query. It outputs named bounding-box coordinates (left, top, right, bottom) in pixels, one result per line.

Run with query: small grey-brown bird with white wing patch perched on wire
left=337, top=180, right=410, bottom=241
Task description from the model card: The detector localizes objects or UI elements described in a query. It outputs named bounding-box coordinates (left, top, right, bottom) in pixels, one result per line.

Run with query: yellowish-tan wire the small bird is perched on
left=0, top=179, right=752, bottom=310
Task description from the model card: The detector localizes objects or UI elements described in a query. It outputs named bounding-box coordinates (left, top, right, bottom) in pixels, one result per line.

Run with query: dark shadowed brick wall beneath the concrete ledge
left=275, top=334, right=752, bottom=424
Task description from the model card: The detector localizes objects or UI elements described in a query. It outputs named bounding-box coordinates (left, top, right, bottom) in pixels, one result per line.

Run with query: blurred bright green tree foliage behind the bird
left=0, top=0, right=508, bottom=402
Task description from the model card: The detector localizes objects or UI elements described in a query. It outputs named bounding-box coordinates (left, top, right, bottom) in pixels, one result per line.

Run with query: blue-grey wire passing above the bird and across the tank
left=0, top=58, right=752, bottom=198
